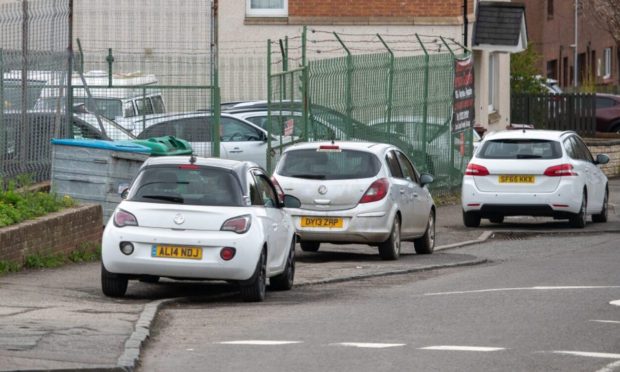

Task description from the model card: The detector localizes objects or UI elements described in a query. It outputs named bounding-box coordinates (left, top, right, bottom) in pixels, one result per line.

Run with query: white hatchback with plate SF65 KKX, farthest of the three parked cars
left=461, top=130, right=609, bottom=228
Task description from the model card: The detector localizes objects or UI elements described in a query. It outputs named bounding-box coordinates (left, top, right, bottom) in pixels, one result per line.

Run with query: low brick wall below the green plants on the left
left=0, top=204, right=102, bottom=263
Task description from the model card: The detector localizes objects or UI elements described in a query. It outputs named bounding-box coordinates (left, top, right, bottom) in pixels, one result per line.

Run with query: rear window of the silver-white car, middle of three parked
left=276, top=149, right=381, bottom=180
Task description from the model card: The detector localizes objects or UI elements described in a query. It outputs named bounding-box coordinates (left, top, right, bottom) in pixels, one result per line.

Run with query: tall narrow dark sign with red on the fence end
left=452, top=56, right=474, bottom=133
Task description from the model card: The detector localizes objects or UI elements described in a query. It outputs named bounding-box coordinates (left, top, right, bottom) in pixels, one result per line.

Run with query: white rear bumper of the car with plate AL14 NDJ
left=102, top=224, right=263, bottom=280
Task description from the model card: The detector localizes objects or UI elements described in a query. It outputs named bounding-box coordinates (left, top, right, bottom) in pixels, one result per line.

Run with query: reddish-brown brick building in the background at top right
left=523, top=0, right=618, bottom=87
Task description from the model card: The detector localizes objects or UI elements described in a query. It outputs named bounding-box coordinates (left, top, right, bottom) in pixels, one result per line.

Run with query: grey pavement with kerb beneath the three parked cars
left=0, top=179, right=620, bottom=371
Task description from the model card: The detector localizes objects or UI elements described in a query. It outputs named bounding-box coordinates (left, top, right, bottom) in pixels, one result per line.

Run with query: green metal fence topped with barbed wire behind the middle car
left=268, top=30, right=473, bottom=195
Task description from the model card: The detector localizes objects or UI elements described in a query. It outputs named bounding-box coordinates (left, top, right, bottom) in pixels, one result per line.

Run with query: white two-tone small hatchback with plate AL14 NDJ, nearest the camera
left=101, top=156, right=299, bottom=301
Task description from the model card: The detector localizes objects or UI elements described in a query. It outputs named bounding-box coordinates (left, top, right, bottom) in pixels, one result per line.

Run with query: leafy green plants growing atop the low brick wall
left=0, top=177, right=76, bottom=227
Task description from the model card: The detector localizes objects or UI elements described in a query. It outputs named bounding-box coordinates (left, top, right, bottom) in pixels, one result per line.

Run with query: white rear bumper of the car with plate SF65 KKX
left=461, top=177, right=582, bottom=218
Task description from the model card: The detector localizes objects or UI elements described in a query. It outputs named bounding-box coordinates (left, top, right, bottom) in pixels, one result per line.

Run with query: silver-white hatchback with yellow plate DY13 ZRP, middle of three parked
left=274, top=142, right=435, bottom=260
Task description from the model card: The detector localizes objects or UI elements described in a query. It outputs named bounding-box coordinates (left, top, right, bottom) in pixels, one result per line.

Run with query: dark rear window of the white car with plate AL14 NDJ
left=127, top=164, right=244, bottom=207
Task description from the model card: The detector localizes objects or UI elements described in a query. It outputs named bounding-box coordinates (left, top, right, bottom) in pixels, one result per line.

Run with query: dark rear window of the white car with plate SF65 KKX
left=476, top=138, right=562, bottom=159
